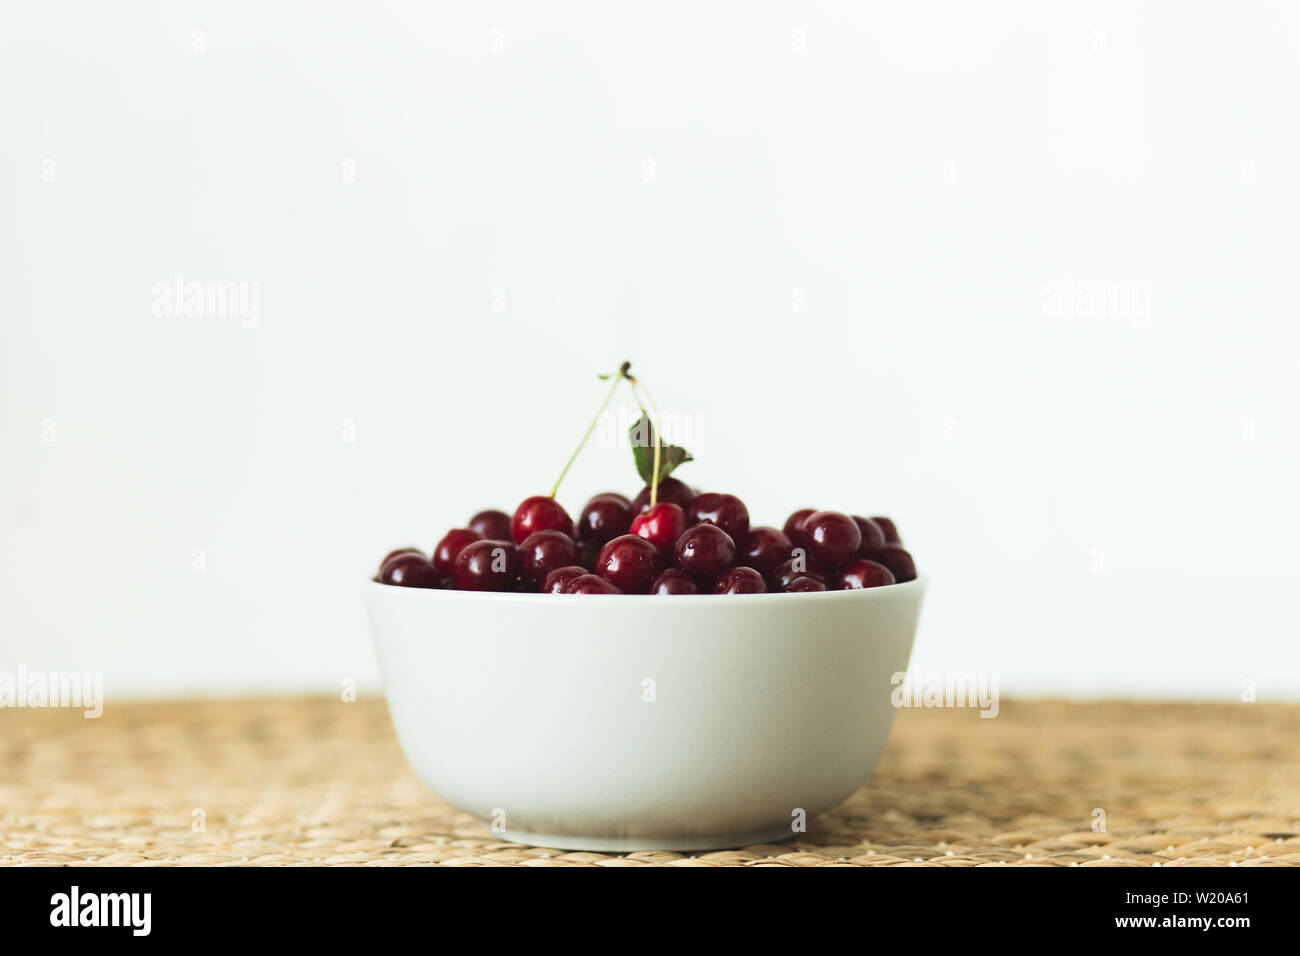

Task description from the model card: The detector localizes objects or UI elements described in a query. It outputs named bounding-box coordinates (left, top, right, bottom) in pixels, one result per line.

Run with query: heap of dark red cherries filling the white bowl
left=376, top=477, right=917, bottom=594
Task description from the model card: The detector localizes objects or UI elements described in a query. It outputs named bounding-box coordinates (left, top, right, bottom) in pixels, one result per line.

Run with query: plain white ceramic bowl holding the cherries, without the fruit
left=365, top=579, right=924, bottom=851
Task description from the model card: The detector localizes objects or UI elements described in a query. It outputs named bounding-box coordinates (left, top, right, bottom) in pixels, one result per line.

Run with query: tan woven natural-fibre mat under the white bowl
left=0, top=698, right=1300, bottom=866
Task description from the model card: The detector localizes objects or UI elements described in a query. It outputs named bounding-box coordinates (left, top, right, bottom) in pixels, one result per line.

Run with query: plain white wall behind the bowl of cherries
left=0, top=0, right=1300, bottom=700
